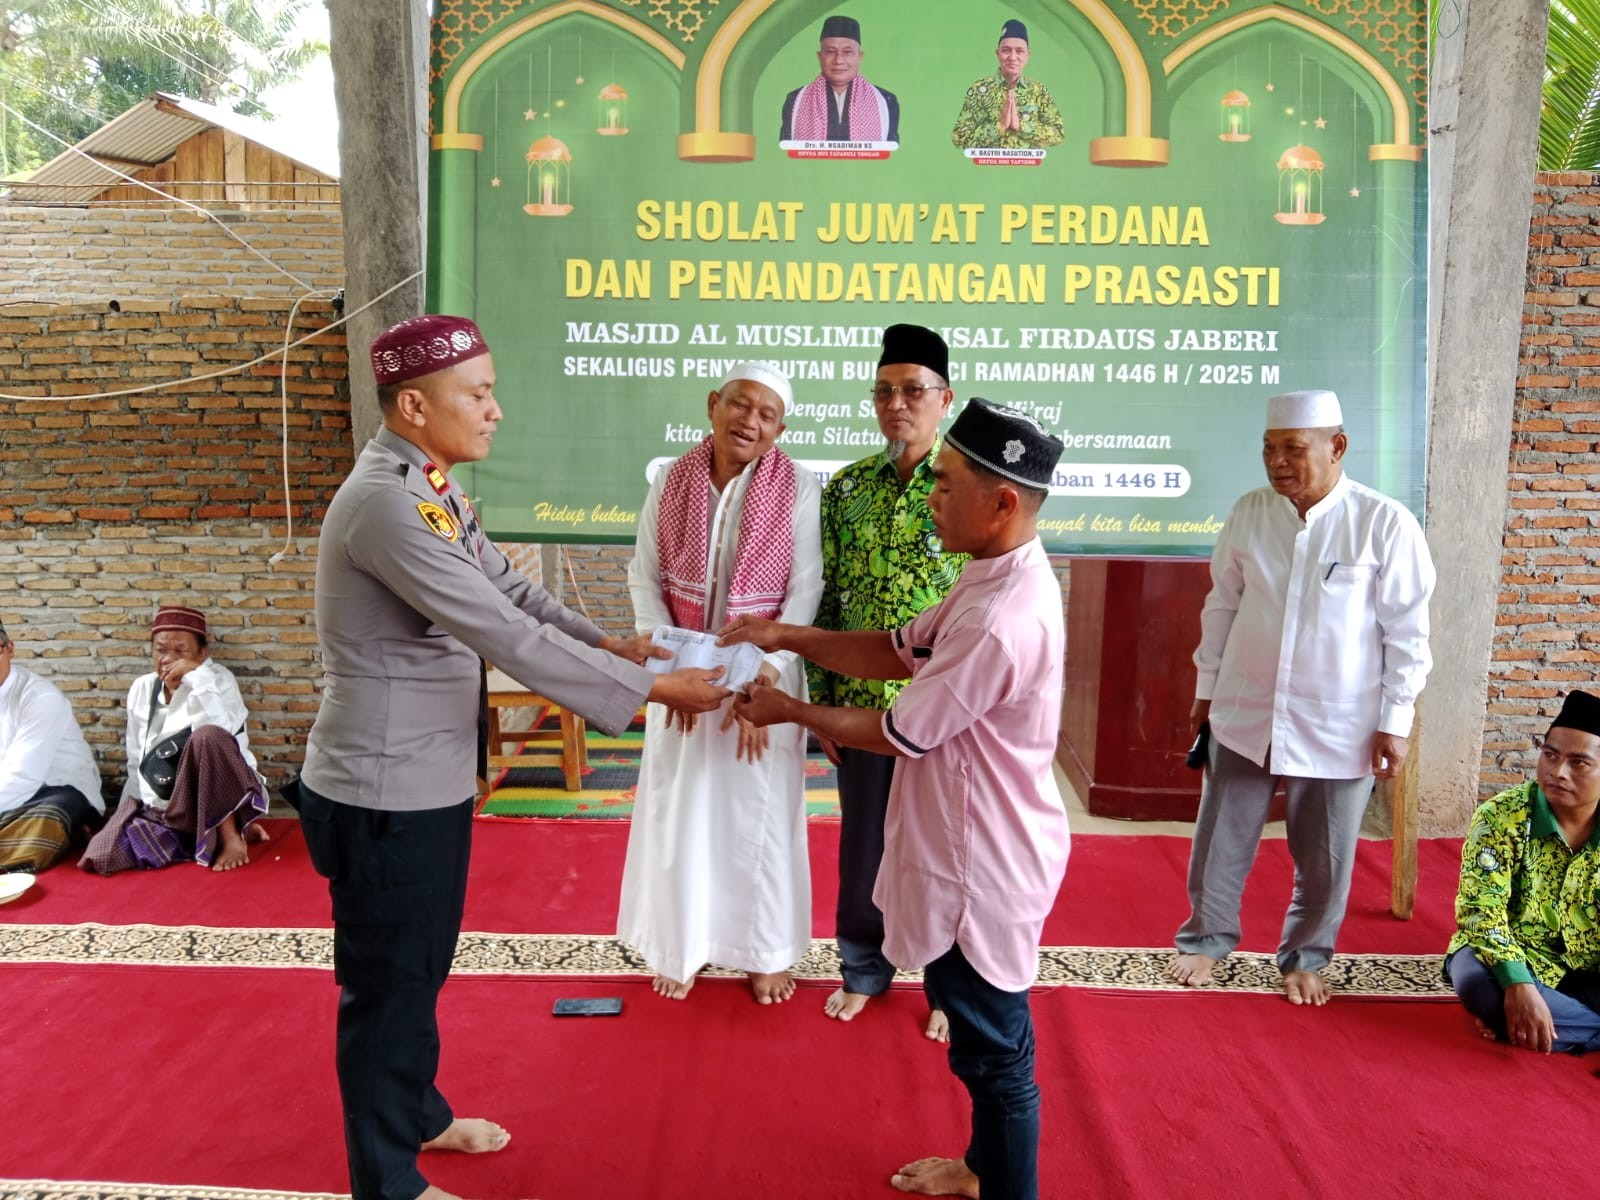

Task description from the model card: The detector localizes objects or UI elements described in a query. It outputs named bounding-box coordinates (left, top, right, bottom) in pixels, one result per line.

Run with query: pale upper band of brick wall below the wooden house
left=0, top=205, right=344, bottom=304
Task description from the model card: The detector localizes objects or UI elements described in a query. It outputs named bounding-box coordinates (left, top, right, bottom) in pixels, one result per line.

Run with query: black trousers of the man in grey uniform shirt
left=298, top=782, right=472, bottom=1200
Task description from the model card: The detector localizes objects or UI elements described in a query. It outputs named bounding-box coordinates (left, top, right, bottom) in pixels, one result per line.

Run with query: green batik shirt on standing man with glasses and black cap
left=806, top=438, right=968, bottom=709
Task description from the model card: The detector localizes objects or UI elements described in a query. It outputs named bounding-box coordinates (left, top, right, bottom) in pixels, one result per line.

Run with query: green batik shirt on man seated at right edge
left=1445, top=781, right=1600, bottom=987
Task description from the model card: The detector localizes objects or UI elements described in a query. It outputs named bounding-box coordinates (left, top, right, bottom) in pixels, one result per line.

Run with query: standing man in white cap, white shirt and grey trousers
left=1168, top=390, right=1434, bottom=1005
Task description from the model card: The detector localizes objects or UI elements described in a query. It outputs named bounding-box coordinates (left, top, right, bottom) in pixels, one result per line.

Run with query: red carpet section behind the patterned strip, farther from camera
left=0, top=821, right=1461, bottom=954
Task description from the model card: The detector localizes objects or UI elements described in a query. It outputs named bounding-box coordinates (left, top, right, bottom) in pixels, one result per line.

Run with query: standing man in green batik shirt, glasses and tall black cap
left=806, top=325, right=966, bottom=1042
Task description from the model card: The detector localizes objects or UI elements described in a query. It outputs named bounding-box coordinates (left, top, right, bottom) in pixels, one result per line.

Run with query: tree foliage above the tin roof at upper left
left=0, top=0, right=326, bottom=178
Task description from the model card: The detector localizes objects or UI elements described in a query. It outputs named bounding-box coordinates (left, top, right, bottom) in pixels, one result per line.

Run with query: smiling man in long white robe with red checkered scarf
left=618, top=362, right=822, bottom=1005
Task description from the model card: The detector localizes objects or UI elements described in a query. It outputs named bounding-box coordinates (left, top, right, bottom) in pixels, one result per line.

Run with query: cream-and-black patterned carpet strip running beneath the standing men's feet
left=0, top=923, right=1454, bottom=998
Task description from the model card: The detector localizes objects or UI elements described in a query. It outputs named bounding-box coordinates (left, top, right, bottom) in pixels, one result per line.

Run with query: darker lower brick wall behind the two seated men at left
left=0, top=294, right=352, bottom=790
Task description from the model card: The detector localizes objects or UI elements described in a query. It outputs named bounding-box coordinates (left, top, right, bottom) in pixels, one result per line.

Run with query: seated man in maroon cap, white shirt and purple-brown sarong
left=78, top=605, right=267, bottom=875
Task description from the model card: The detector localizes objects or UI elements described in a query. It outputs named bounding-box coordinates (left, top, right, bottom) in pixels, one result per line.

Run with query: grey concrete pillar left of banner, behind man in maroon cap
left=326, top=0, right=429, bottom=448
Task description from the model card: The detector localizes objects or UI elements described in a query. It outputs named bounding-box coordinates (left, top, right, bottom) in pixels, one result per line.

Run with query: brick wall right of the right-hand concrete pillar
left=1480, top=173, right=1600, bottom=795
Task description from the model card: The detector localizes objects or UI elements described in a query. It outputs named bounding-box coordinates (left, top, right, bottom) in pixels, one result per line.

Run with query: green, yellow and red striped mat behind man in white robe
left=480, top=720, right=838, bottom=821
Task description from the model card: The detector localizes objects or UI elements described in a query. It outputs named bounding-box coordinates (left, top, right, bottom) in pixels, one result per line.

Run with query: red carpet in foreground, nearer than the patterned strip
left=0, top=965, right=1600, bottom=1200
